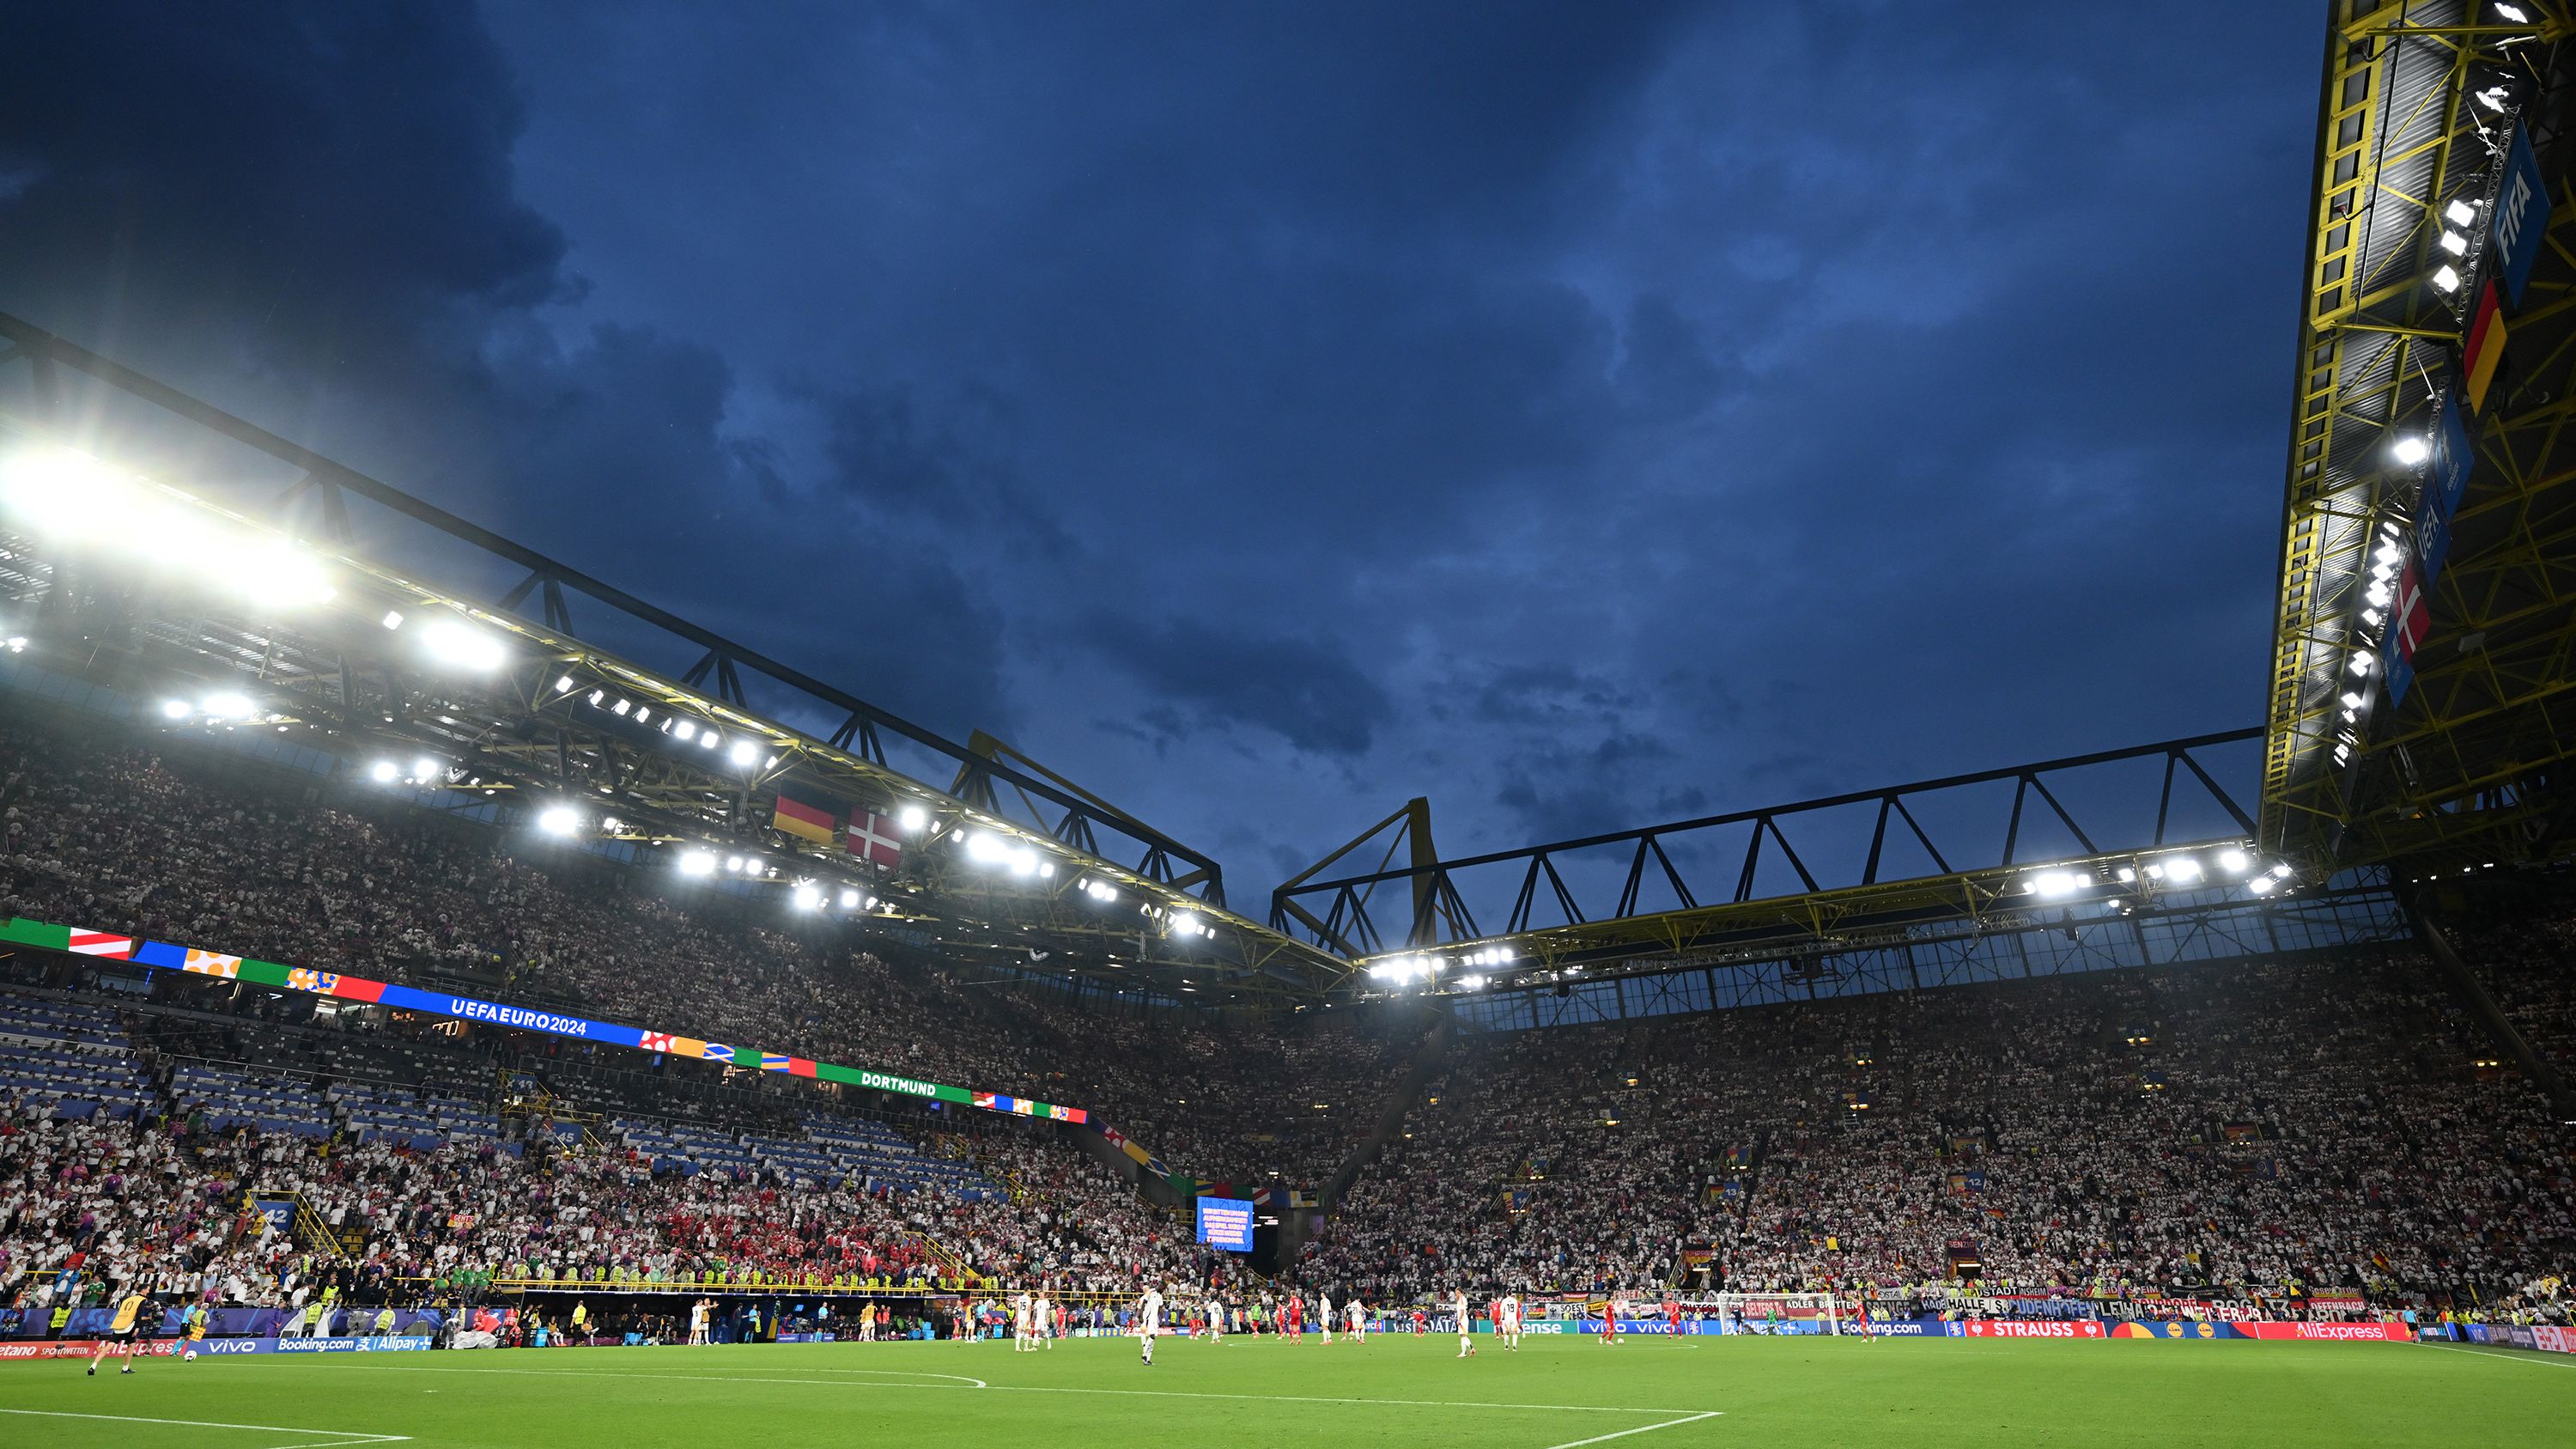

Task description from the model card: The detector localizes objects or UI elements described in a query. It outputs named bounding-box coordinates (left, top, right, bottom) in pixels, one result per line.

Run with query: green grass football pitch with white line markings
left=0, top=1338, right=2576, bottom=1449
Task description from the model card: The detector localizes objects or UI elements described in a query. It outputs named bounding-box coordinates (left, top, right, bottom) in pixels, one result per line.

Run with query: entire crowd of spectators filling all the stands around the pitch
left=0, top=714, right=2576, bottom=1302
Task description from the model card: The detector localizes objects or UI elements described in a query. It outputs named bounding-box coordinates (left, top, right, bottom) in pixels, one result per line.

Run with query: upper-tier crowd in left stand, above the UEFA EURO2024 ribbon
left=0, top=714, right=1430, bottom=1191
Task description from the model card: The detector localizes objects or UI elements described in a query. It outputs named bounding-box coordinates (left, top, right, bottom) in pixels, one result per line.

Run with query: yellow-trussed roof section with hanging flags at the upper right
left=2259, top=0, right=2576, bottom=877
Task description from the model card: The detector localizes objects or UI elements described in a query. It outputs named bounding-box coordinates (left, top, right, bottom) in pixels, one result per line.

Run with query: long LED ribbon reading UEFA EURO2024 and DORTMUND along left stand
left=0, top=916, right=1090, bottom=1124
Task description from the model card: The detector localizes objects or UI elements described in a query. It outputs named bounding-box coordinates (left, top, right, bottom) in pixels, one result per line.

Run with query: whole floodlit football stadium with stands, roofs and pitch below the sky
left=0, top=0, right=2576, bottom=1449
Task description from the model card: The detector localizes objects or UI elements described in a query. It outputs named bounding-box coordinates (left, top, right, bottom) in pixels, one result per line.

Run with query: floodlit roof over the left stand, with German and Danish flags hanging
left=0, top=304, right=1350, bottom=1006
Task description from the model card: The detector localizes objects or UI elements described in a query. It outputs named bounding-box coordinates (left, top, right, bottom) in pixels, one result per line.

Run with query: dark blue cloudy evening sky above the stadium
left=0, top=3, right=2321, bottom=900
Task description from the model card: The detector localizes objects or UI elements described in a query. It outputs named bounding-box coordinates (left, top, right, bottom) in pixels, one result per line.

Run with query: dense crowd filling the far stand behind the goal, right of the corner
left=1303, top=954, right=2576, bottom=1297
